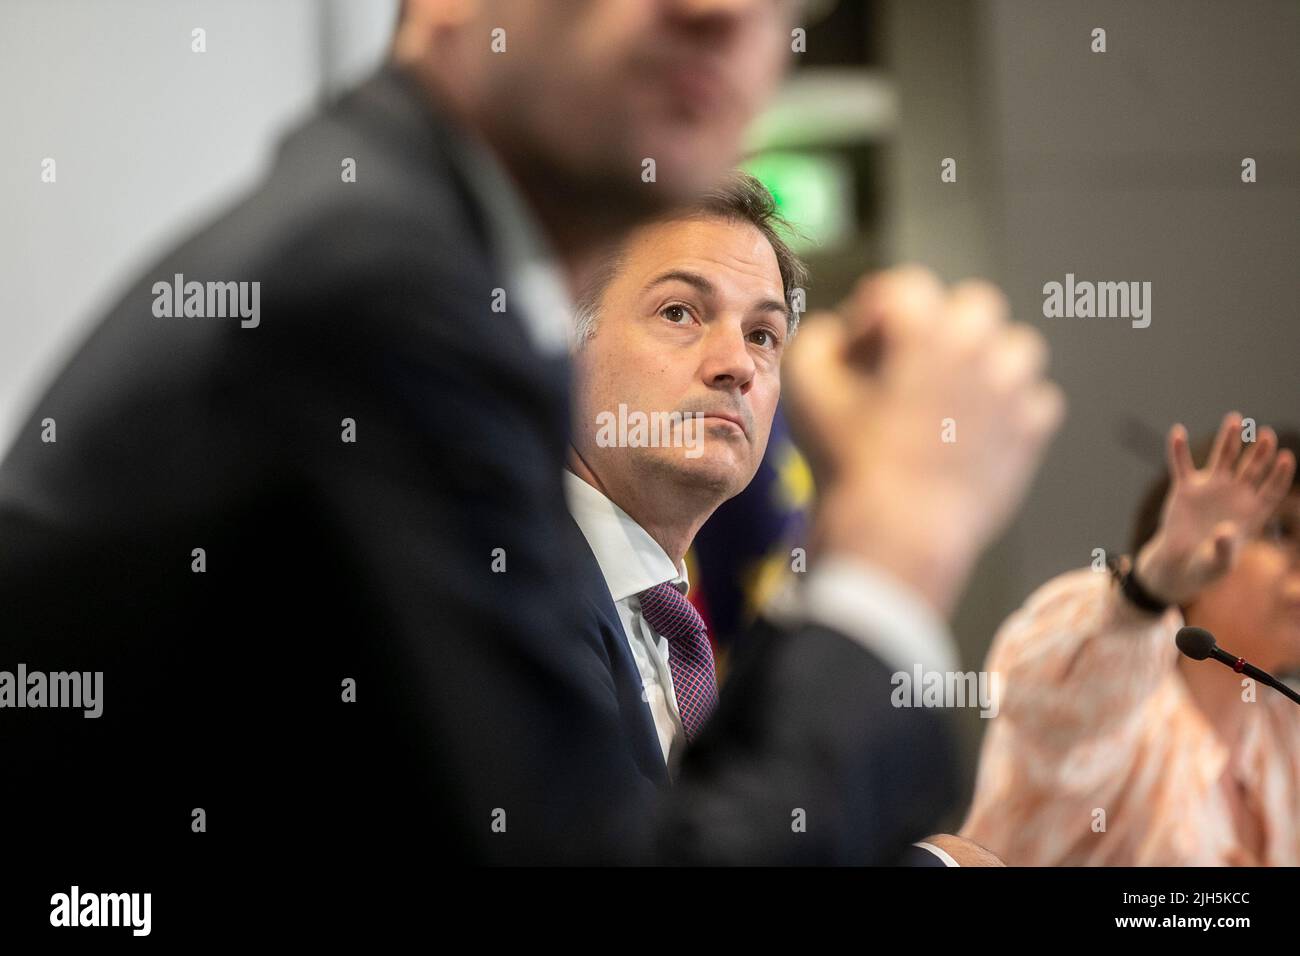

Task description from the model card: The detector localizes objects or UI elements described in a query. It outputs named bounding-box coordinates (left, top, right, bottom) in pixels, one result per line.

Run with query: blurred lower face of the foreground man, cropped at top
left=471, top=0, right=802, bottom=213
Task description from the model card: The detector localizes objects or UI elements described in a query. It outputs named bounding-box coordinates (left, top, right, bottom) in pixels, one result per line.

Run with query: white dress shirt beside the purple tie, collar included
left=564, top=470, right=689, bottom=766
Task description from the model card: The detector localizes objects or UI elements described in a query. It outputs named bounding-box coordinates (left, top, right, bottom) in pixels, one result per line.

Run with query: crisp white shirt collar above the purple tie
left=564, top=468, right=690, bottom=602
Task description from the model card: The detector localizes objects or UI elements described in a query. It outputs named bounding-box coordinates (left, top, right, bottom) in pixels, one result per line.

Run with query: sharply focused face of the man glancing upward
left=573, top=217, right=788, bottom=502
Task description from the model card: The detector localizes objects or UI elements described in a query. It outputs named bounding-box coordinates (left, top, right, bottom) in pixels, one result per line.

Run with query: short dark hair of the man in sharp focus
left=575, top=170, right=809, bottom=343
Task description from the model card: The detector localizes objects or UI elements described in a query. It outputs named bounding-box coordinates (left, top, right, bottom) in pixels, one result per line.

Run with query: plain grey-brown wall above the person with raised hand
left=888, top=0, right=1300, bottom=796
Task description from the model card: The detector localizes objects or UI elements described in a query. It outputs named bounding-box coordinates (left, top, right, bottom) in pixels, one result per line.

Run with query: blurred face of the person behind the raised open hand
left=1187, top=490, right=1300, bottom=670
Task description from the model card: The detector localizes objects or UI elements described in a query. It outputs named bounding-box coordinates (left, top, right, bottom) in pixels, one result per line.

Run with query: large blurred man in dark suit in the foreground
left=0, top=0, right=1053, bottom=875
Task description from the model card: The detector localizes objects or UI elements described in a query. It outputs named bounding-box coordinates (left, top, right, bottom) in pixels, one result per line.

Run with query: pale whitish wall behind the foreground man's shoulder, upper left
left=0, top=0, right=397, bottom=447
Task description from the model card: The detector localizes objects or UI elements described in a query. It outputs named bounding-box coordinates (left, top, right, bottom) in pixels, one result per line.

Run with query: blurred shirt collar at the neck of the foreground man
left=450, top=121, right=573, bottom=355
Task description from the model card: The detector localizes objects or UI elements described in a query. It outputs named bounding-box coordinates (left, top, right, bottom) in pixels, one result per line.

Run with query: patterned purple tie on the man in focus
left=637, top=581, right=718, bottom=741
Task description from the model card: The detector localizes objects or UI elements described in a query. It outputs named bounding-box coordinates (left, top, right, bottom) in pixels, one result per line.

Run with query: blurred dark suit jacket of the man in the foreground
left=0, top=70, right=953, bottom=864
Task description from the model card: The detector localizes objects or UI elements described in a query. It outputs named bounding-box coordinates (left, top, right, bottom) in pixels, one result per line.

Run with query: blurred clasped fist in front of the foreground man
left=783, top=267, right=1065, bottom=613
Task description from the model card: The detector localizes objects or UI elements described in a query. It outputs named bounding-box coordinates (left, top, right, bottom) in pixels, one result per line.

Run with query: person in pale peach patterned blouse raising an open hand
left=961, top=412, right=1300, bottom=866
